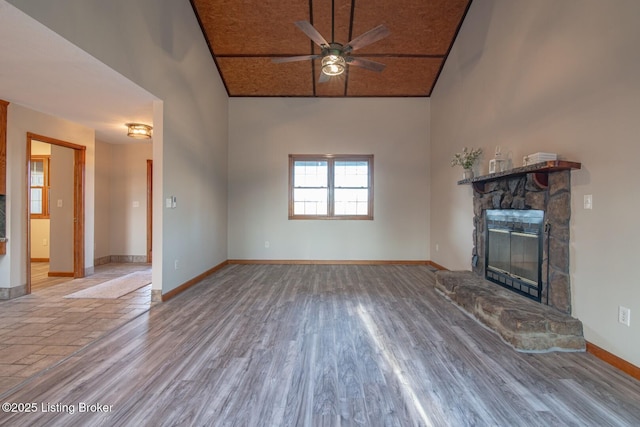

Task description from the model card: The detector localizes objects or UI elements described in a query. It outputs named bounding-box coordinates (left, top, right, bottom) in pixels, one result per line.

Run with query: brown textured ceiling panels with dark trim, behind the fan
left=191, top=0, right=472, bottom=97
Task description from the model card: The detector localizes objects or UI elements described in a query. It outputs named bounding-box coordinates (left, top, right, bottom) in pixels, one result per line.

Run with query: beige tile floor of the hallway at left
left=0, top=264, right=151, bottom=396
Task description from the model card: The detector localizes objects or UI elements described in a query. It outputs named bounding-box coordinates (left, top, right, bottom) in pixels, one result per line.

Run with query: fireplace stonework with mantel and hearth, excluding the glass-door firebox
left=435, top=161, right=585, bottom=352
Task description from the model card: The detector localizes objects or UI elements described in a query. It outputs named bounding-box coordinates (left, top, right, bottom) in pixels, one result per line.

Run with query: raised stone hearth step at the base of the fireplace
left=435, top=271, right=586, bottom=352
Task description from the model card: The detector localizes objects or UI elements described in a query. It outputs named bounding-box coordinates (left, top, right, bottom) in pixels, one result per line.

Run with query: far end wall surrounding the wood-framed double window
left=229, top=98, right=430, bottom=260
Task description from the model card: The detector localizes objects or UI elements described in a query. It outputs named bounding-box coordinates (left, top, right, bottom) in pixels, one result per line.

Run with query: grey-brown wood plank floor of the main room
left=0, top=265, right=640, bottom=426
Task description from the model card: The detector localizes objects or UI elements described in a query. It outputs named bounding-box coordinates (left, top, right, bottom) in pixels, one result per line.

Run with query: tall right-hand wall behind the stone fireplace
left=431, top=0, right=640, bottom=366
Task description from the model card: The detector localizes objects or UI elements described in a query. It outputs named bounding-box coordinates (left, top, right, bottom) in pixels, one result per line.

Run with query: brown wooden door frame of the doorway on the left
left=25, top=132, right=87, bottom=294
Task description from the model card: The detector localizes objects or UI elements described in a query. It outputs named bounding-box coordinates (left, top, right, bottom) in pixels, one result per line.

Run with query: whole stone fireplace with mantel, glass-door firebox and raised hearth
left=435, top=161, right=586, bottom=352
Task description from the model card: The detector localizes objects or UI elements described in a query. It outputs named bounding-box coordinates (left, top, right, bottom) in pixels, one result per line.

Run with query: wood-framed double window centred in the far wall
left=289, top=154, right=373, bottom=219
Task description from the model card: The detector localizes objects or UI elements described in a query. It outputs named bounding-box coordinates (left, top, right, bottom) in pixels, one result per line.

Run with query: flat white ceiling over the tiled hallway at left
left=0, top=0, right=158, bottom=144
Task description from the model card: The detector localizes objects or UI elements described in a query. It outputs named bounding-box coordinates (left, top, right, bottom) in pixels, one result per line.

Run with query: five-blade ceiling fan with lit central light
left=272, top=21, right=389, bottom=83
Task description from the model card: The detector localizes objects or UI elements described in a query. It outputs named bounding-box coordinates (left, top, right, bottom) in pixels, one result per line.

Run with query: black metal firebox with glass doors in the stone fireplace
left=485, top=209, right=544, bottom=302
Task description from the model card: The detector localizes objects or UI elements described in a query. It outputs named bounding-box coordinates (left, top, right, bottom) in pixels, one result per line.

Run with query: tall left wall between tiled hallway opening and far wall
left=10, top=0, right=228, bottom=293
